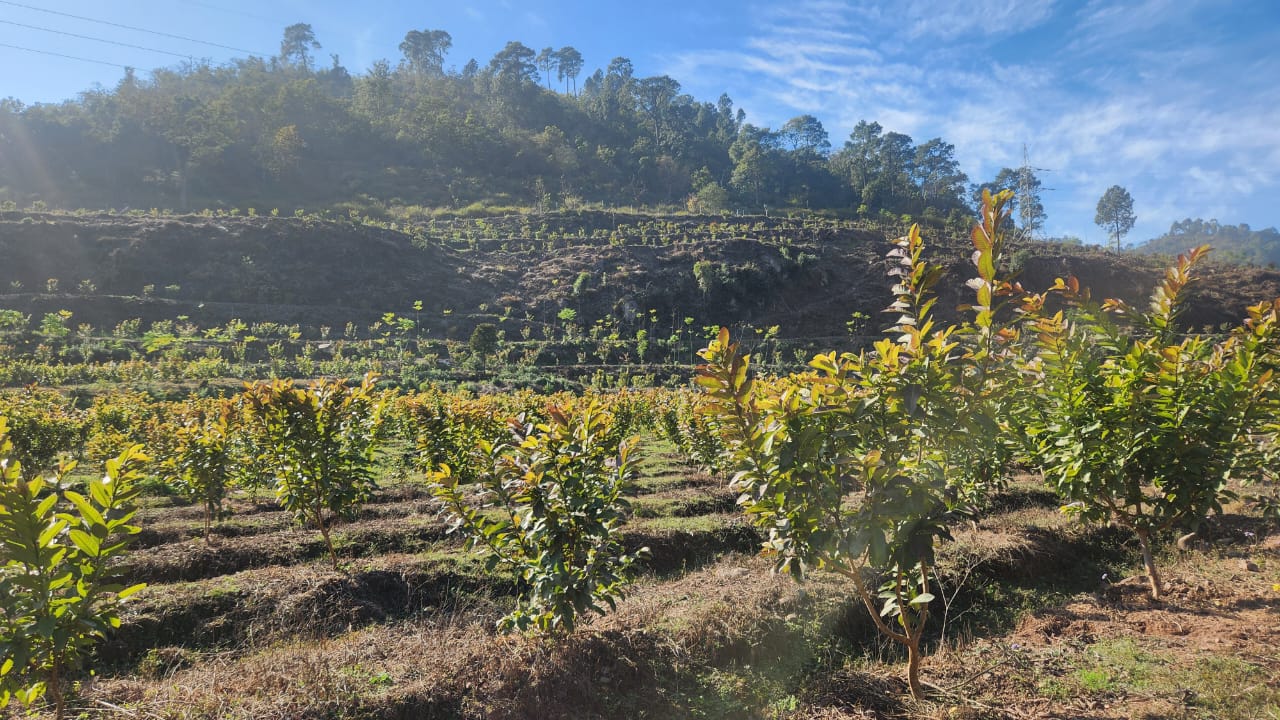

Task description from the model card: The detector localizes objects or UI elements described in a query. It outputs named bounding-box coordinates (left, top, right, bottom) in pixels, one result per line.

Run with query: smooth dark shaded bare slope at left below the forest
left=0, top=213, right=494, bottom=327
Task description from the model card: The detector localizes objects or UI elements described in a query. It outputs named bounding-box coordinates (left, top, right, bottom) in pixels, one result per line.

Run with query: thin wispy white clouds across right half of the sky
left=669, top=0, right=1280, bottom=237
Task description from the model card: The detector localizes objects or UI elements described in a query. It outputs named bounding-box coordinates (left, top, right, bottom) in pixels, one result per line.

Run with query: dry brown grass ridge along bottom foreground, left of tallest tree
left=79, top=556, right=865, bottom=719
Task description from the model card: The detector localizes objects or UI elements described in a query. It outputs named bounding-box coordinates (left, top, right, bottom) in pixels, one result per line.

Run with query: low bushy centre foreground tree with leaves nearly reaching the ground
left=429, top=402, right=648, bottom=633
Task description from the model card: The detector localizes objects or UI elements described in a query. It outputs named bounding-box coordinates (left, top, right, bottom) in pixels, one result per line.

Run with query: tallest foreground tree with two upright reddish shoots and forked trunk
left=698, top=192, right=1018, bottom=698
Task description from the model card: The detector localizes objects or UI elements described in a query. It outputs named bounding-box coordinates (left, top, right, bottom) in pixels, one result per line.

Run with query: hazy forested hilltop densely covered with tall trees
left=0, top=24, right=1018, bottom=224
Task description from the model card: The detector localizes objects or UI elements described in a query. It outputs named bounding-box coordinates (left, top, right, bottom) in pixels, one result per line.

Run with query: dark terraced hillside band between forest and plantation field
left=0, top=211, right=1280, bottom=345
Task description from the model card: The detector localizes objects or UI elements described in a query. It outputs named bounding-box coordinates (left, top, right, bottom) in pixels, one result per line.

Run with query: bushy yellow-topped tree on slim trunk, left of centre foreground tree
left=244, top=374, right=387, bottom=570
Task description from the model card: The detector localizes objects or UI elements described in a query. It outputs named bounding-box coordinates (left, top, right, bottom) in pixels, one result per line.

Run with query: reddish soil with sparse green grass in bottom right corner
left=920, top=520, right=1280, bottom=720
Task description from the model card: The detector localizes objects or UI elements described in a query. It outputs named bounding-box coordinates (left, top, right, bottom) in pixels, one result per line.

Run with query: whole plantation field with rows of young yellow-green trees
left=0, top=191, right=1280, bottom=720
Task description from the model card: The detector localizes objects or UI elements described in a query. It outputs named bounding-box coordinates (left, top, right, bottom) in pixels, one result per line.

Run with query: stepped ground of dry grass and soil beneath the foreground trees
left=12, top=437, right=1280, bottom=719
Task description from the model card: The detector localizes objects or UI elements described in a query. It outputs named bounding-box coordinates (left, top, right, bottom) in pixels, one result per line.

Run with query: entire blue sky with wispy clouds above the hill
left=0, top=0, right=1280, bottom=242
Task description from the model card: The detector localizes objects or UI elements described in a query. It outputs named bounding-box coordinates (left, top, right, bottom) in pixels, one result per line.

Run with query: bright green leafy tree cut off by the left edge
left=0, top=418, right=147, bottom=719
